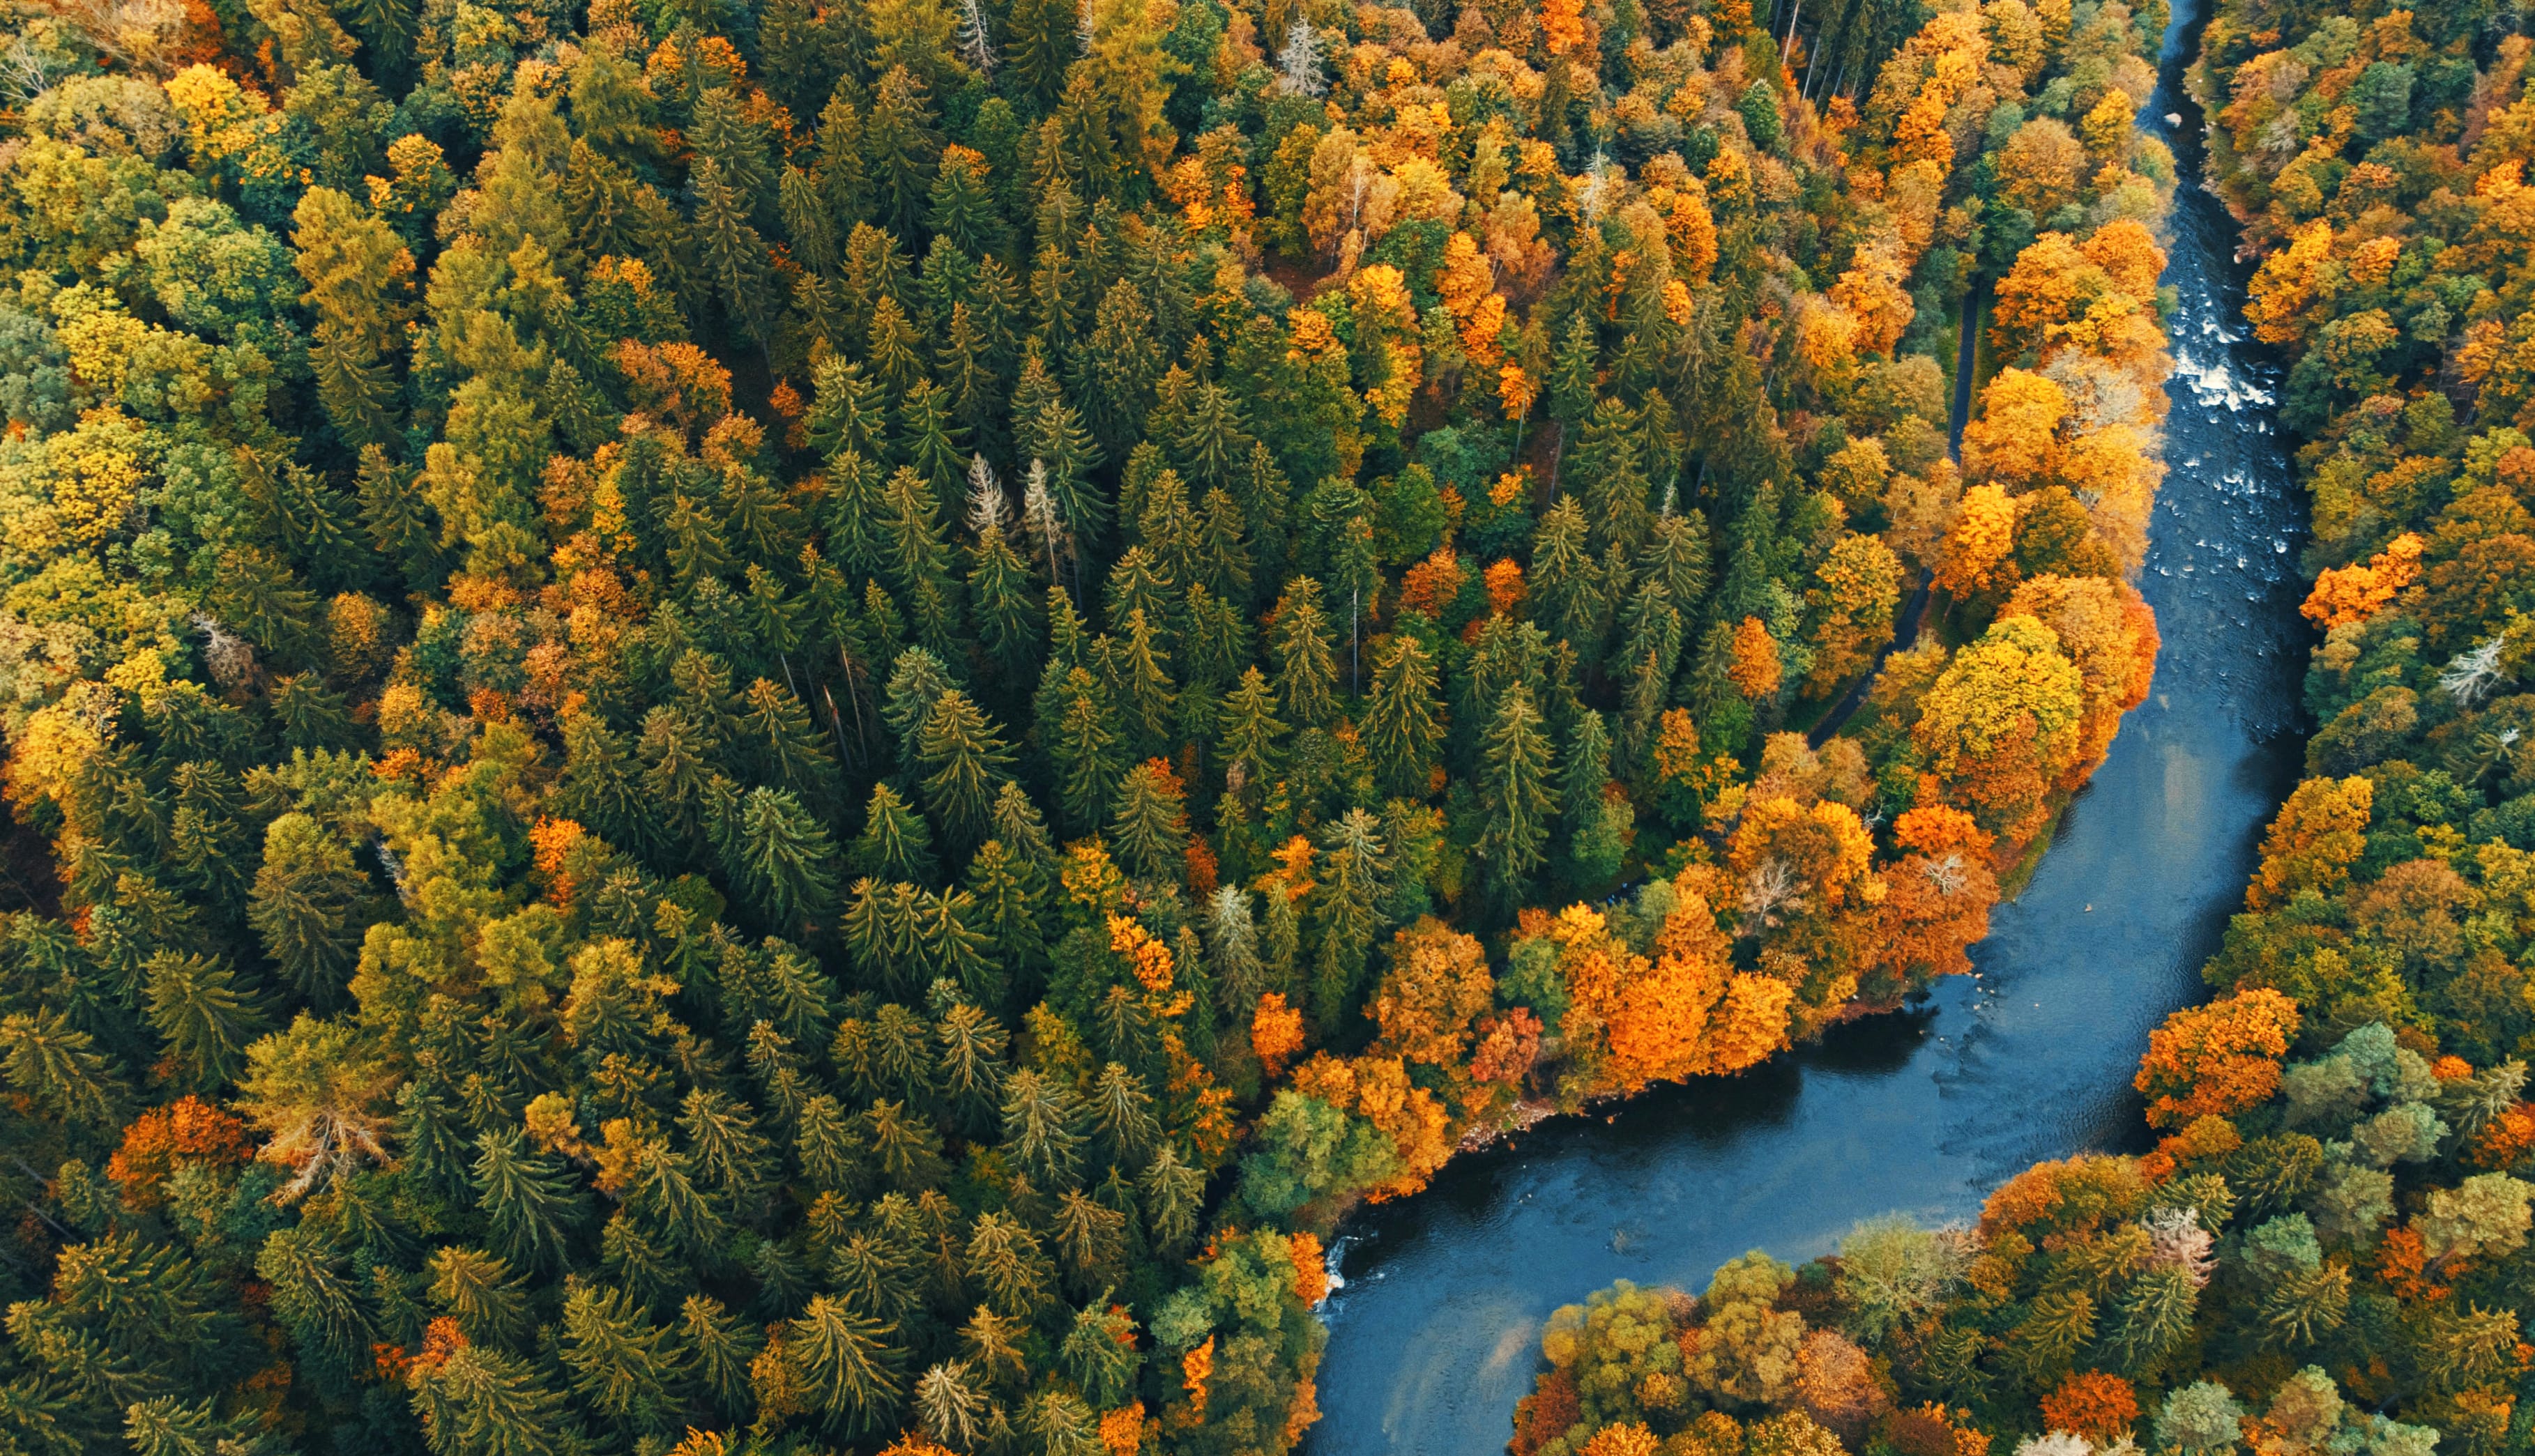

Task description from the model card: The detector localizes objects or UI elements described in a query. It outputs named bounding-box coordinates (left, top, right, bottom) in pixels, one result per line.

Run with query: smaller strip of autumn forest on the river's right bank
left=1514, top=0, right=2535, bottom=1456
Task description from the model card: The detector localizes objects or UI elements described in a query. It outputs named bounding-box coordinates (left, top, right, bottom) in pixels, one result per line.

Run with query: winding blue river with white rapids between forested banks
left=1308, top=0, right=2307, bottom=1456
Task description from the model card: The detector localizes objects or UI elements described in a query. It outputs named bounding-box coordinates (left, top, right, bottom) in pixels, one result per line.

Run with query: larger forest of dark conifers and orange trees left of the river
left=0, top=0, right=2200, bottom=1456
